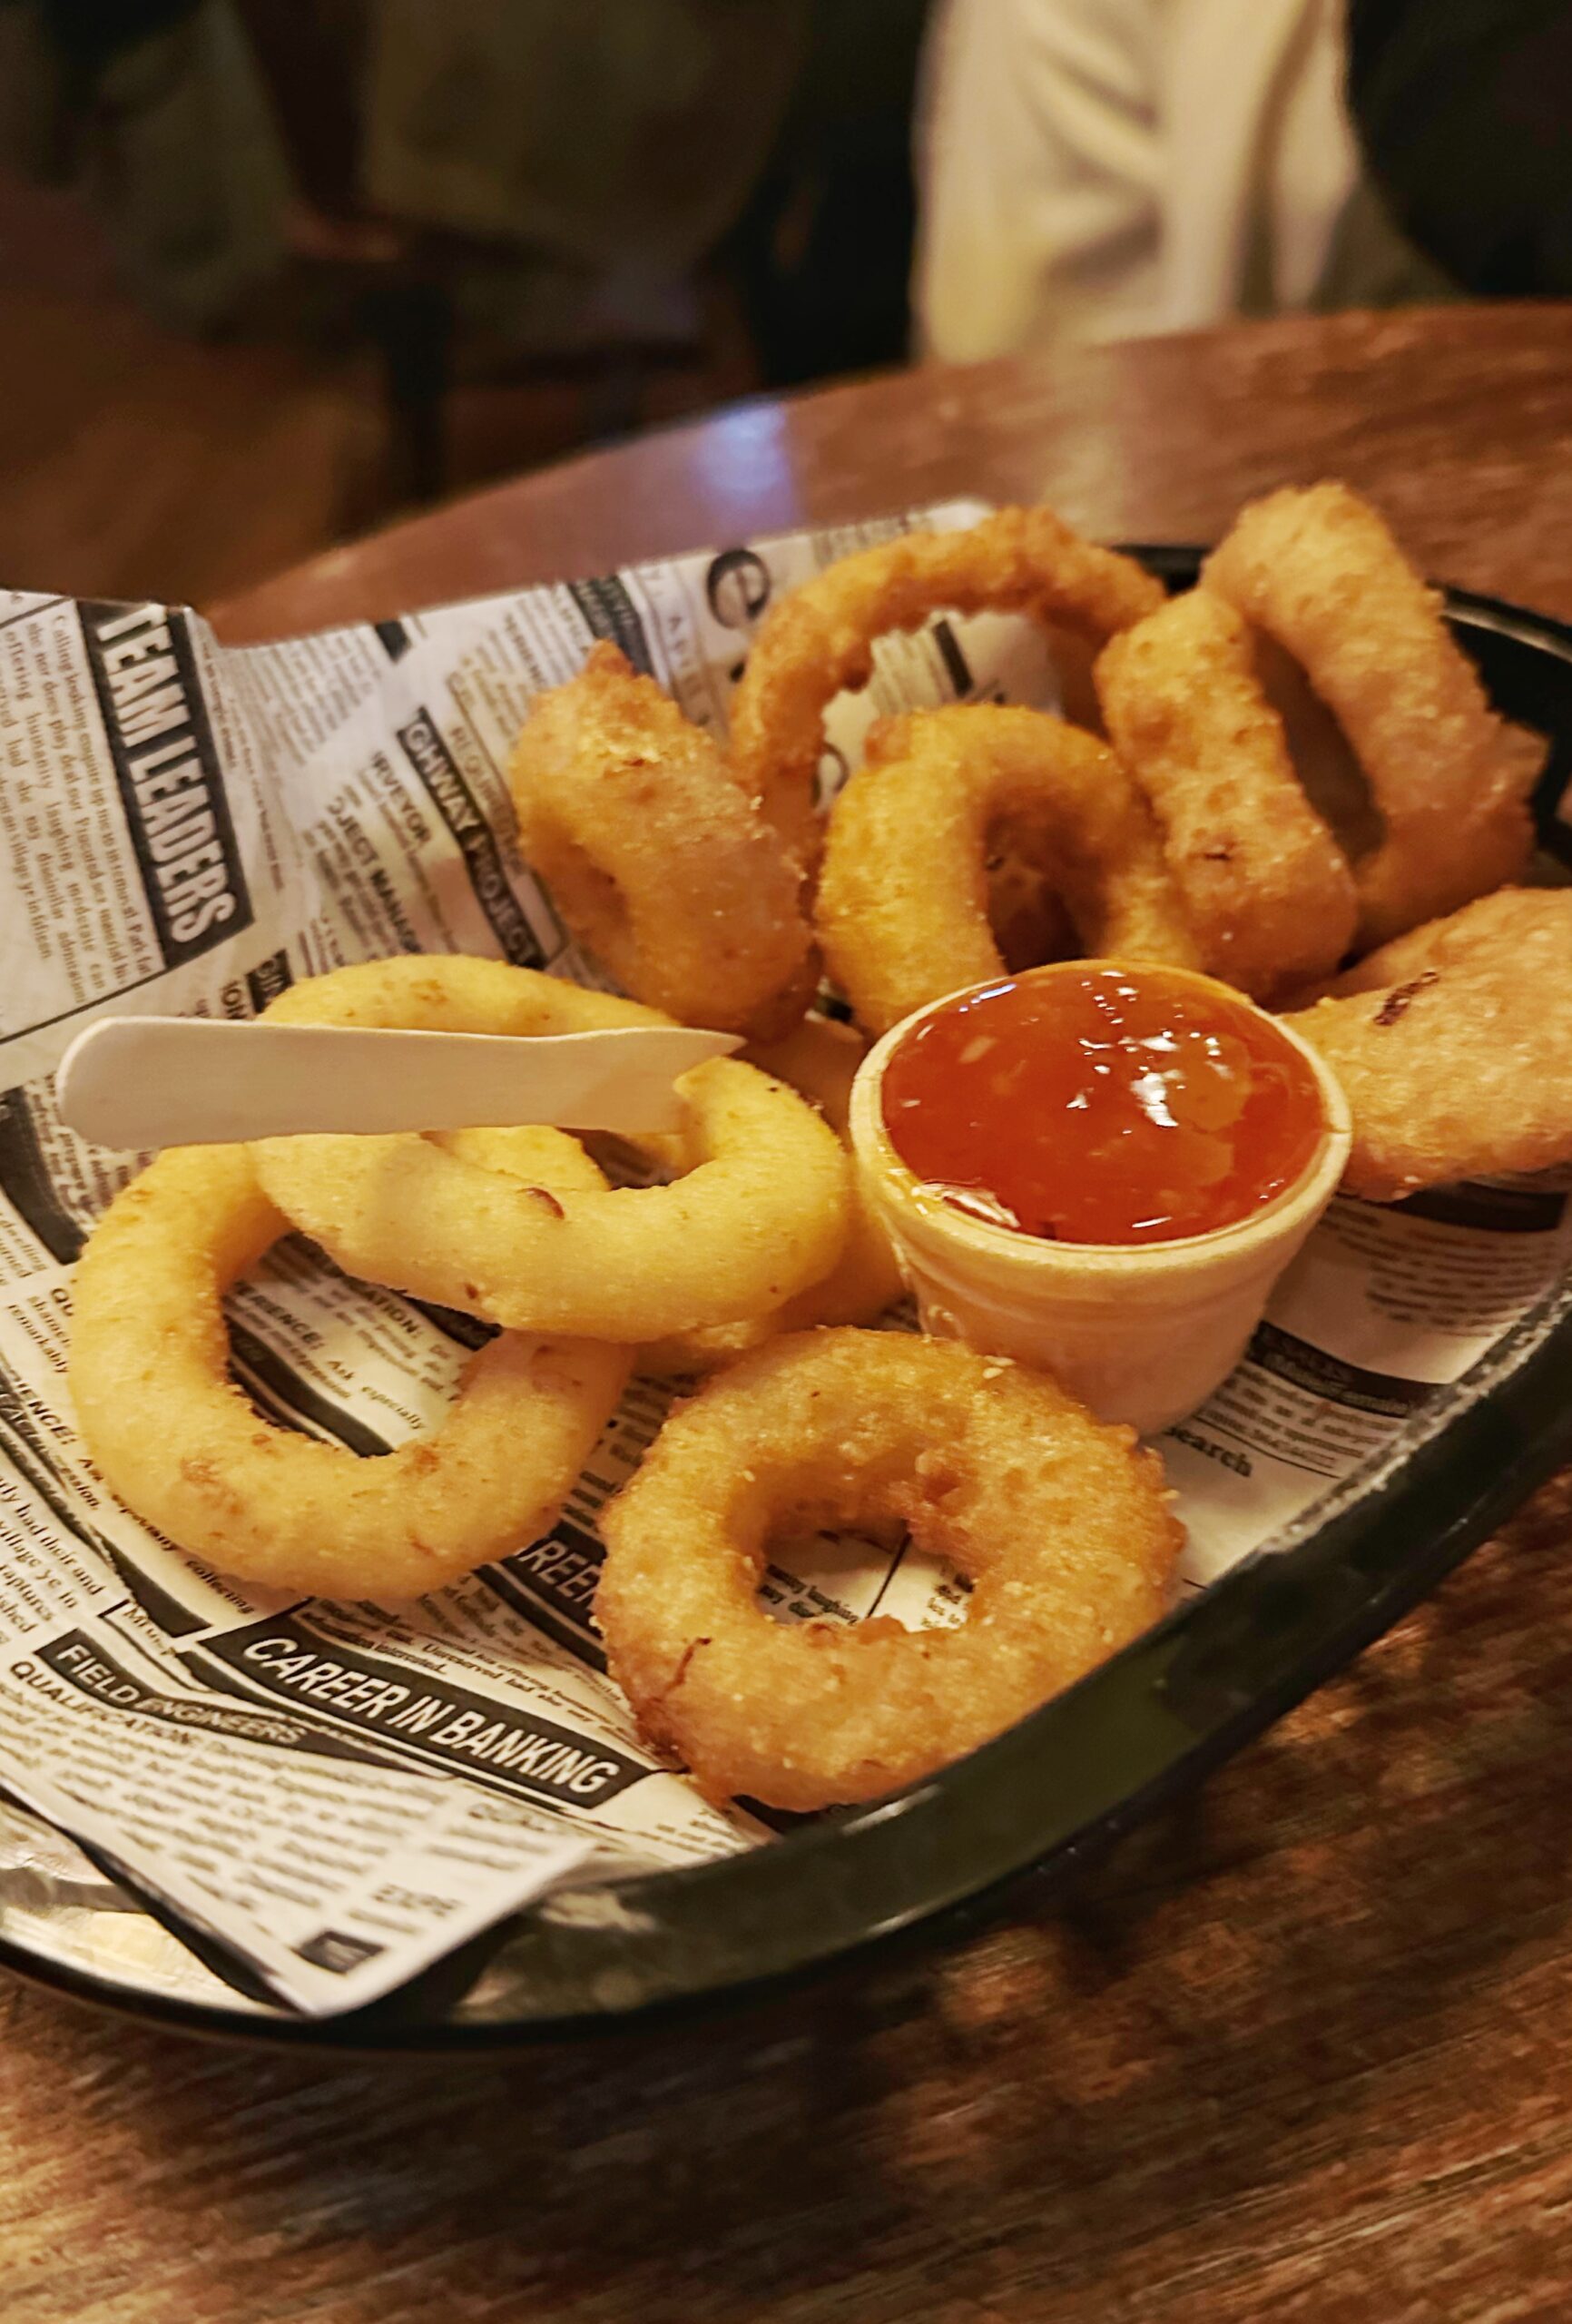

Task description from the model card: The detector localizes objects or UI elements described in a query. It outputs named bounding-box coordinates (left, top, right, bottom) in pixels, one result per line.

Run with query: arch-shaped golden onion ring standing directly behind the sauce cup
left=815, top=704, right=1201, bottom=1034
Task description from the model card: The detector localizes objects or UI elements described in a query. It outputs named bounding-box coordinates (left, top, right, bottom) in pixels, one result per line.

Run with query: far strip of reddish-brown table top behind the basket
left=216, top=304, right=1572, bottom=639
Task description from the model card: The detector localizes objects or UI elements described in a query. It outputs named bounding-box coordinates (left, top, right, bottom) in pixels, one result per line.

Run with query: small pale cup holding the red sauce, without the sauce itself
left=850, top=960, right=1349, bottom=1434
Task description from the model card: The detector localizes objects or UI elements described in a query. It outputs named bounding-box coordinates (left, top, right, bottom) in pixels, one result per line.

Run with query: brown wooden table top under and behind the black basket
left=0, top=309, right=1572, bottom=2324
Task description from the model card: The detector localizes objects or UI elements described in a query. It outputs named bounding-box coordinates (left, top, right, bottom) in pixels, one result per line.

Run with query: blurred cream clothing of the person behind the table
left=915, top=0, right=1447, bottom=362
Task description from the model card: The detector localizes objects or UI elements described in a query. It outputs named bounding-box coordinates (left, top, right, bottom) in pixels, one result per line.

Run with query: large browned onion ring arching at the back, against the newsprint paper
left=732, top=509, right=1164, bottom=872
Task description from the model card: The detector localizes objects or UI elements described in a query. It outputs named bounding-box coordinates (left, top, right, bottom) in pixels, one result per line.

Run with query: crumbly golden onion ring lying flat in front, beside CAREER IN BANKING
left=594, top=1332, right=1184, bottom=1808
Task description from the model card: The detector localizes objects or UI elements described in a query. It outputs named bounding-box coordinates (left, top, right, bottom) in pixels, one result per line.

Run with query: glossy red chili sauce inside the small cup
left=882, top=962, right=1323, bottom=1244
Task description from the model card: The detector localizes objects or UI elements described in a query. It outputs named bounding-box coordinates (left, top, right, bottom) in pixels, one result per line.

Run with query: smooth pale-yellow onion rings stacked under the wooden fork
left=70, top=958, right=859, bottom=1601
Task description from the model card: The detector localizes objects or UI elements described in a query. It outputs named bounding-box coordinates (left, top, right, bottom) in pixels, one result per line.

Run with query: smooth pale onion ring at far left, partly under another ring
left=70, top=1132, right=629, bottom=1599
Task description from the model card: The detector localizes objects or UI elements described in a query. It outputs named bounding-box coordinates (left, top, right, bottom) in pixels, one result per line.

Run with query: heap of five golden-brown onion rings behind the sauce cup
left=499, top=483, right=1530, bottom=1041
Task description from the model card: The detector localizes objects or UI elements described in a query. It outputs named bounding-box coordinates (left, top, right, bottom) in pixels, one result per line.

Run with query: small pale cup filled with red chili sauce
left=850, top=960, right=1349, bottom=1434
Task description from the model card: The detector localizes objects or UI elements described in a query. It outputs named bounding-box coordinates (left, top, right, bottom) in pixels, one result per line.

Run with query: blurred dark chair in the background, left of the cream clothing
left=237, top=0, right=806, bottom=499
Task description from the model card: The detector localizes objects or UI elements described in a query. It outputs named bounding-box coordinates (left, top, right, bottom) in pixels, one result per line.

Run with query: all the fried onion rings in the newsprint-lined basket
left=70, top=486, right=1572, bottom=1808
